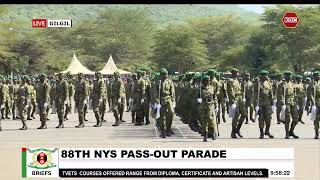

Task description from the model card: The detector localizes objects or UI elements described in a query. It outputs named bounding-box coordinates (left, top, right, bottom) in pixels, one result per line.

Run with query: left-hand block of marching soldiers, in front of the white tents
left=0, top=69, right=175, bottom=137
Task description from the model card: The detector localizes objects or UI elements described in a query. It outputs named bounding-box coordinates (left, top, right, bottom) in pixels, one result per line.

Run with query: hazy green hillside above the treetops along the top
left=0, top=5, right=260, bottom=26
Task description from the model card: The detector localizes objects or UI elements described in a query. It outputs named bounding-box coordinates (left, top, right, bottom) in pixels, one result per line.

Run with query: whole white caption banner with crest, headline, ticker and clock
left=22, top=148, right=294, bottom=178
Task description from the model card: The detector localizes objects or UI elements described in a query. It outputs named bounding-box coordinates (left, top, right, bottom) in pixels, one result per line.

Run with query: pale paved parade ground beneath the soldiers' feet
left=0, top=111, right=320, bottom=180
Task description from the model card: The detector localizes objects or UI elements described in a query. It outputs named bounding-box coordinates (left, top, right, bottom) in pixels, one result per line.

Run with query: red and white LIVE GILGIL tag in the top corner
left=32, top=19, right=72, bottom=28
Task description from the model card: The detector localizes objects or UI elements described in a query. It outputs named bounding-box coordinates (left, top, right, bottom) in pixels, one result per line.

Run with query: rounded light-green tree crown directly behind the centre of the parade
left=152, top=25, right=209, bottom=73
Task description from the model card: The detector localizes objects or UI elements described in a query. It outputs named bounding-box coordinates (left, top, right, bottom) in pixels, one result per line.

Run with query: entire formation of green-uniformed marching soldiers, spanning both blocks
left=0, top=68, right=320, bottom=142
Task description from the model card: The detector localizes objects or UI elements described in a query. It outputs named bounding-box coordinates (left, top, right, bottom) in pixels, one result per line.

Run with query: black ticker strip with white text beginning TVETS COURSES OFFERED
left=59, top=169, right=269, bottom=178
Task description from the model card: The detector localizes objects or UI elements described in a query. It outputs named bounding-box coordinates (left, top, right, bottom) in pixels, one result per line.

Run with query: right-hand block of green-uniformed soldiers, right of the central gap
left=176, top=68, right=320, bottom=141
